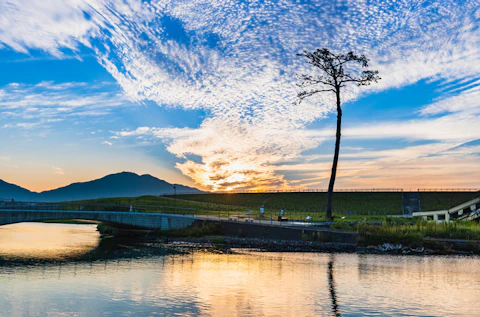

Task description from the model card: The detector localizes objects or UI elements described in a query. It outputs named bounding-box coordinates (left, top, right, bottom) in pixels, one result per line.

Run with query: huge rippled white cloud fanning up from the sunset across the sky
left=0, top=0, right=480, bottom=189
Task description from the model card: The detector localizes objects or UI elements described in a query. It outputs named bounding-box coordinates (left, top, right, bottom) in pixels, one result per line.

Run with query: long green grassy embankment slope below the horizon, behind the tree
left=67, top=192, right=480, bottom=222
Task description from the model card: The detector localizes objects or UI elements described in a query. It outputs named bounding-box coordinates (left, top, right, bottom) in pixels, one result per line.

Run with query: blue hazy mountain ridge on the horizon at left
left=0, top=172, right=201, bottom=202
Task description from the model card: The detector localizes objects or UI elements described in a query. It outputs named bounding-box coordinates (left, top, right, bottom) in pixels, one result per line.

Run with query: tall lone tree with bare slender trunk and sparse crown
left=297, top=48, right=380, bottom=219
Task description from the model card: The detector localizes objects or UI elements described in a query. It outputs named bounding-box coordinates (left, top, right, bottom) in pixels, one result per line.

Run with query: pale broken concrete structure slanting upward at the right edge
left=412, top=197, right=480, bottom=223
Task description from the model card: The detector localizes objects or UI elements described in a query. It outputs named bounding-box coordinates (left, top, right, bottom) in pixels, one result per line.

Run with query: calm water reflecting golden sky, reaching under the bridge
left=0, top=224, right=480, bottom=317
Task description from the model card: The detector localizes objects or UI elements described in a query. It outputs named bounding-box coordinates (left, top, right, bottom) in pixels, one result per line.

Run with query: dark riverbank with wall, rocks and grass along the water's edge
left=98, top=221, right=480, bottom=255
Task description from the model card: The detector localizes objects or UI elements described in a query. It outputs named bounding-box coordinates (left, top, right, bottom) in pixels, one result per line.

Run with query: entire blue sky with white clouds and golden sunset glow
left=0, top=0, right=480, bottom=191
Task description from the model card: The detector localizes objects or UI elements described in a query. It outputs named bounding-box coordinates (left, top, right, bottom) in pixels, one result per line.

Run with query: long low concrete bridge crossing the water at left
left=0, top=209, right=195, bottom=230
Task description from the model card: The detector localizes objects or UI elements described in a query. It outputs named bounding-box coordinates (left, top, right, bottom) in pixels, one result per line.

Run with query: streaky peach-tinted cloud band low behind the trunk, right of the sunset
left=277, top=142, right=480, bottom=190
